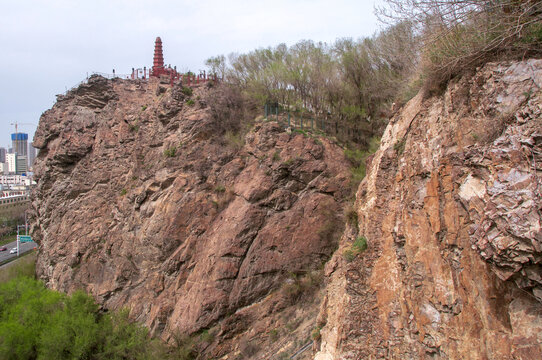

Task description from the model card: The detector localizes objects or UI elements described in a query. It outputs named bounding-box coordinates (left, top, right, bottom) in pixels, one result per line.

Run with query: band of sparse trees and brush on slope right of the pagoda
left=206, top=0, right=542, bottom=148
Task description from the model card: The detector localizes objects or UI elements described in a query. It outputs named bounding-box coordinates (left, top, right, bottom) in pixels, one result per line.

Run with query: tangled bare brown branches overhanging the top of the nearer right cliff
left=377, top=0, right=542, bottom=87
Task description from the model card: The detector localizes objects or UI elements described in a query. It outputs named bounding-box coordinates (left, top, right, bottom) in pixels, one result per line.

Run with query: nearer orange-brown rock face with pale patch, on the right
left=315, top=60, right=542, bottom=360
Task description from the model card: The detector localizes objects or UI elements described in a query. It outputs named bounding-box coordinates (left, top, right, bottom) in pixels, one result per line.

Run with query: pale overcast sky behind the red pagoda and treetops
left=0, top=0, right=381, bottom=148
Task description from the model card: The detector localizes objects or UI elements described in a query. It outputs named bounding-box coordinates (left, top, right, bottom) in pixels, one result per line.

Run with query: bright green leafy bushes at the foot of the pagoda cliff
left=0, top=276, right=167, bottom=359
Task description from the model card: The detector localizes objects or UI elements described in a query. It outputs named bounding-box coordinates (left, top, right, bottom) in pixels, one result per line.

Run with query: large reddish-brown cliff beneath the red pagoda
left=33, top=77, right=349, bottom=358
